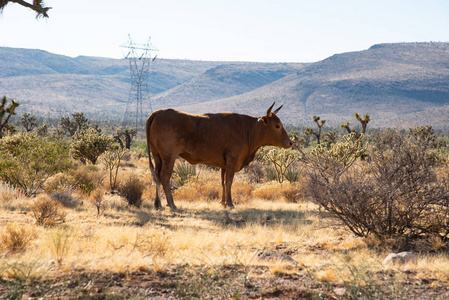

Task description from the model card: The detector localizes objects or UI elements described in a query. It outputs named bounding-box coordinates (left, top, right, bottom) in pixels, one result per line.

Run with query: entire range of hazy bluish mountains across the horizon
left=0, top=43, right=449, bottom=129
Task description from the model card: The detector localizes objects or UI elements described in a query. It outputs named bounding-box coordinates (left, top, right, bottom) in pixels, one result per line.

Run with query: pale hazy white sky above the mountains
left=0, top=0, right=449, bottom=62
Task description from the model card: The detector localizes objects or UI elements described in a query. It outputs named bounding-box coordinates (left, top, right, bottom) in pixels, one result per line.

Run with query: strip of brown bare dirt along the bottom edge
left=0, top=258, right=449, bottom=299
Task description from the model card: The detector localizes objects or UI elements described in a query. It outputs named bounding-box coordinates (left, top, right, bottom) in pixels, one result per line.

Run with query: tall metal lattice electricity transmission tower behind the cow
left=120, top=36, right=157, bottom=132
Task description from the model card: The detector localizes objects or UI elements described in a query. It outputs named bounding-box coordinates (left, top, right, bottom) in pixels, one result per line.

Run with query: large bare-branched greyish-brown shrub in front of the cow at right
left=308, top=130, right=449, bottom=239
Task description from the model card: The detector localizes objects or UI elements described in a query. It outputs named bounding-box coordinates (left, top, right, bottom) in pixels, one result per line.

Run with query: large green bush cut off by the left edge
left=0, top=133, right=72, bottom=196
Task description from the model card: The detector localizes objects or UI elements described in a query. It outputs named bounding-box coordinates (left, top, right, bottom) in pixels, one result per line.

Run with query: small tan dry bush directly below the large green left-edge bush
left=30, top=195, right=67, bottom=226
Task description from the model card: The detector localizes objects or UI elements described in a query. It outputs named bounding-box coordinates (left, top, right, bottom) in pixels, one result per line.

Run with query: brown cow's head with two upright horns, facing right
left=259, top=102, right=293, bottom=148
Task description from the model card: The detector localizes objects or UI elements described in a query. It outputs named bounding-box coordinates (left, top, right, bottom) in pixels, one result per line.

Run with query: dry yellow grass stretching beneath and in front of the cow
left=0, top=162, right=449, bottom=296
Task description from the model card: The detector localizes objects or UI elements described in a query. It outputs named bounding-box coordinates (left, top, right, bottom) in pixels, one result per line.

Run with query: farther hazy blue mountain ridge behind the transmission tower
left=0, top=47, right=302, bottom=118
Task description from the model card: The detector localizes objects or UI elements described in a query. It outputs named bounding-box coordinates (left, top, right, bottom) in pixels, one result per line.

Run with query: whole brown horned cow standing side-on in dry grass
left=146, top=103, right=292, bottom=209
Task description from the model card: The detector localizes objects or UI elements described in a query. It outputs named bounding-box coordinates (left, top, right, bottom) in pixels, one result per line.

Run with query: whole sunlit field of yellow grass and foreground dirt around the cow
left=0, top=158, right=449, bottom=299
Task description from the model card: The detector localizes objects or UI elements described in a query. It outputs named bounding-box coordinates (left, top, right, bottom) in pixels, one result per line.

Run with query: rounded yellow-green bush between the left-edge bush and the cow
left=70, top=128, right=114, bottom=165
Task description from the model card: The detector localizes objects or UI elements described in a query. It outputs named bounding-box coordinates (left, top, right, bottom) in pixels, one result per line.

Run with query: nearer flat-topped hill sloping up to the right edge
left=180, top=43, right=449, bottom=129
